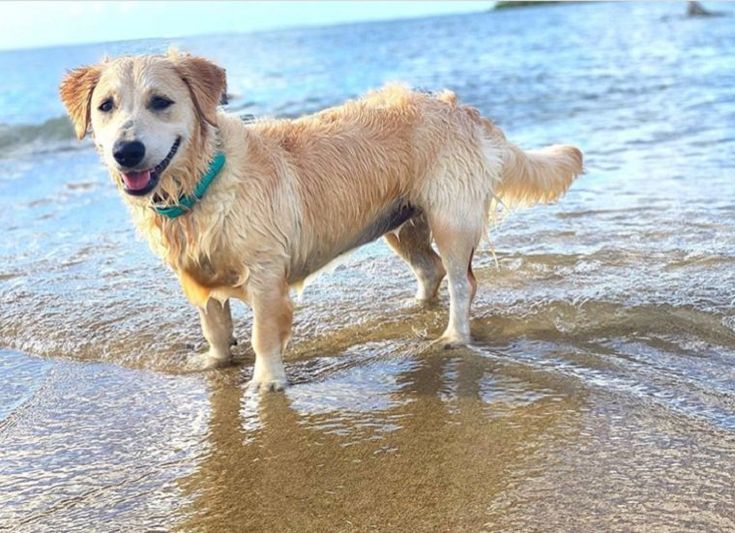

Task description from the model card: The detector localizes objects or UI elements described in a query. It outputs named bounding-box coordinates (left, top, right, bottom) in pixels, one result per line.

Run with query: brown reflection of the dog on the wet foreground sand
left=181, top=349, right=580, bottom=531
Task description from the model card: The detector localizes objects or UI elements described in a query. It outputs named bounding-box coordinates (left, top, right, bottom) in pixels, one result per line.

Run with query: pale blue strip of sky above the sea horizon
left=0, top=0, right=493, bottom=50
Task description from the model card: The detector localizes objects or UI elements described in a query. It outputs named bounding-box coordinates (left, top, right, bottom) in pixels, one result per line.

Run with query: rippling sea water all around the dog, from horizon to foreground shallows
left=0, top=3, right=735, bottom=531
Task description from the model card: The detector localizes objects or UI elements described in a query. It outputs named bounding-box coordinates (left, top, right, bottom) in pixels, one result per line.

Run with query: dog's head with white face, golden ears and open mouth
left=60, top=52, right=225, bottom=201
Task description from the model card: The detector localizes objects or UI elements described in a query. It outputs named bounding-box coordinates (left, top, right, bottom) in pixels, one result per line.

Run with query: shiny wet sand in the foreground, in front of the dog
left=0, top=332, right=735, bottom=531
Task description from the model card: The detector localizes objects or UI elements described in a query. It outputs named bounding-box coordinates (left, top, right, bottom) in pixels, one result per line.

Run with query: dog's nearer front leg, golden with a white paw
left=249, top=279, right=293, bottom=391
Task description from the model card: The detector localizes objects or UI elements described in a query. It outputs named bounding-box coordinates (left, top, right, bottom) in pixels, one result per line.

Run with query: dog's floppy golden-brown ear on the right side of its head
left=169, top=52, right=227, bottom=126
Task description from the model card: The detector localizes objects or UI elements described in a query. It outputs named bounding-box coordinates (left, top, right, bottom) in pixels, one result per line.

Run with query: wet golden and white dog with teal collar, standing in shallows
left=60, top=51, right=582, bottom=390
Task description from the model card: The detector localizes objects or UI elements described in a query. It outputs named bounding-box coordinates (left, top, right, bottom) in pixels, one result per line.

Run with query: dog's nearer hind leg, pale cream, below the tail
left=431, top=208, right=483, bottom=347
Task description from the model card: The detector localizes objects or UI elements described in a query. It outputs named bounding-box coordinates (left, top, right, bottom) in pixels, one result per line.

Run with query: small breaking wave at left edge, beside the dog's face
left=0, top=115, right=82, bottom=159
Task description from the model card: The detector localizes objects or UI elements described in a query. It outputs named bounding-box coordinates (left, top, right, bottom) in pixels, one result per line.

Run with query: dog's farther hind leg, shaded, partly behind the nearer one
left=385, top=215, right=446, bottom=301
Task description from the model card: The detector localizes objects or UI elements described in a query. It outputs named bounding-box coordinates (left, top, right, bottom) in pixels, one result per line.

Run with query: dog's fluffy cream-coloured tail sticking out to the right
left=494, top=143, right=584, bottom=208
